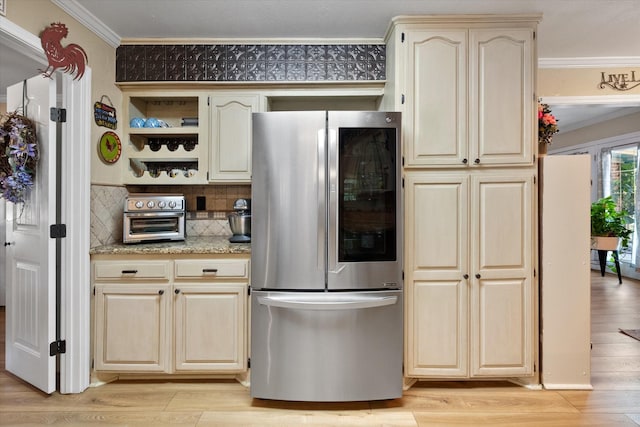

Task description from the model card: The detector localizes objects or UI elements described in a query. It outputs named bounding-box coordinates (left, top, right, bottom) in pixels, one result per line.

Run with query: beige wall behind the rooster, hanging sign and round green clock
left=6, top=0, right=122, bottom=184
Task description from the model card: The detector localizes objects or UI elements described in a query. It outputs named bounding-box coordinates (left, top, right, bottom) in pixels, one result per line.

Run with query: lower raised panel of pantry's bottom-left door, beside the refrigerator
left=405, top=280, right=468, bottom=377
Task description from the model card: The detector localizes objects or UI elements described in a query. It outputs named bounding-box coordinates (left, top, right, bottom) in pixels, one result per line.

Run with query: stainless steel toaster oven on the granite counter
left=122, top=193, right=186, bottom=243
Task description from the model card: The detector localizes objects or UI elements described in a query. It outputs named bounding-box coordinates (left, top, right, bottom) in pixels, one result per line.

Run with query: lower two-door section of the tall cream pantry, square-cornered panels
left=405, top=169, right=535, bottom=378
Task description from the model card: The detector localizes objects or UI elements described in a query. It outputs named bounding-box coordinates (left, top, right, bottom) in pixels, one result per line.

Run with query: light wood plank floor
left=0, top=273, right=640, bottom=427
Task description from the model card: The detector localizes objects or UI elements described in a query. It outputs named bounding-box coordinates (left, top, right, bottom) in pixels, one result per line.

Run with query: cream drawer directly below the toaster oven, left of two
left=93, top=261, right=171, bottom=280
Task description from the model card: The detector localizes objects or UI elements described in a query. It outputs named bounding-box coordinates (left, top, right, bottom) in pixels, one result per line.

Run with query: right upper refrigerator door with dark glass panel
left=327, top=111, right=402, bottom=290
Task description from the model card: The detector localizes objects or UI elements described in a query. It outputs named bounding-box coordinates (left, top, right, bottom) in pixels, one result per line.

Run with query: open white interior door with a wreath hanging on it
left=5, top=75, right=56, bottom=393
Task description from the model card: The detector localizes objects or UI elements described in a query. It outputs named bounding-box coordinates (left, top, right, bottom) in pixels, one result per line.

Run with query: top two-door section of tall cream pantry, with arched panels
left=385, top=17, right=537, bottom=168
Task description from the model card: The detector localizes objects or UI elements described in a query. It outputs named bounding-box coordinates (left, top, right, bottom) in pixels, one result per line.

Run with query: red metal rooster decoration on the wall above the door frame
left=40, top=22, right=87, bottom=80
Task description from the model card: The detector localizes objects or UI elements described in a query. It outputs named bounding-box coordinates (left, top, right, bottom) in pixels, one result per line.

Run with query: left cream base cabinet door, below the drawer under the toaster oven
left=95, top=284, right=171, bottom=372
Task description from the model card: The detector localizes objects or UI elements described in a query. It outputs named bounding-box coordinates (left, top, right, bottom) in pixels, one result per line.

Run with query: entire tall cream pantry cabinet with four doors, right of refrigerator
left=383, top=15, right=539, bottom=378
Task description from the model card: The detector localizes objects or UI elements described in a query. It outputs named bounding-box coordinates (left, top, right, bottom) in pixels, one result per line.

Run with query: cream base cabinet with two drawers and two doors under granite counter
left=92, top=256, right=249, bottom=374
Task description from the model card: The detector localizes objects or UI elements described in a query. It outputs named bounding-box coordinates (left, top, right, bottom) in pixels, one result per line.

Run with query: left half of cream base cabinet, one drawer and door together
left=93, top=260, right=172, bottom=372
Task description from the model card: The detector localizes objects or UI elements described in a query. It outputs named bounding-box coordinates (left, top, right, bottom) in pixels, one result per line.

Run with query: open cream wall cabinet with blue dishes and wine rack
left=122, top=91, right=208, bottom=184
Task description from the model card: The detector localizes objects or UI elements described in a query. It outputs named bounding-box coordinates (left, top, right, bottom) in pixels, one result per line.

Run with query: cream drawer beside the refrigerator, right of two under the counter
left=175, top=259, right=249, bottom=279
